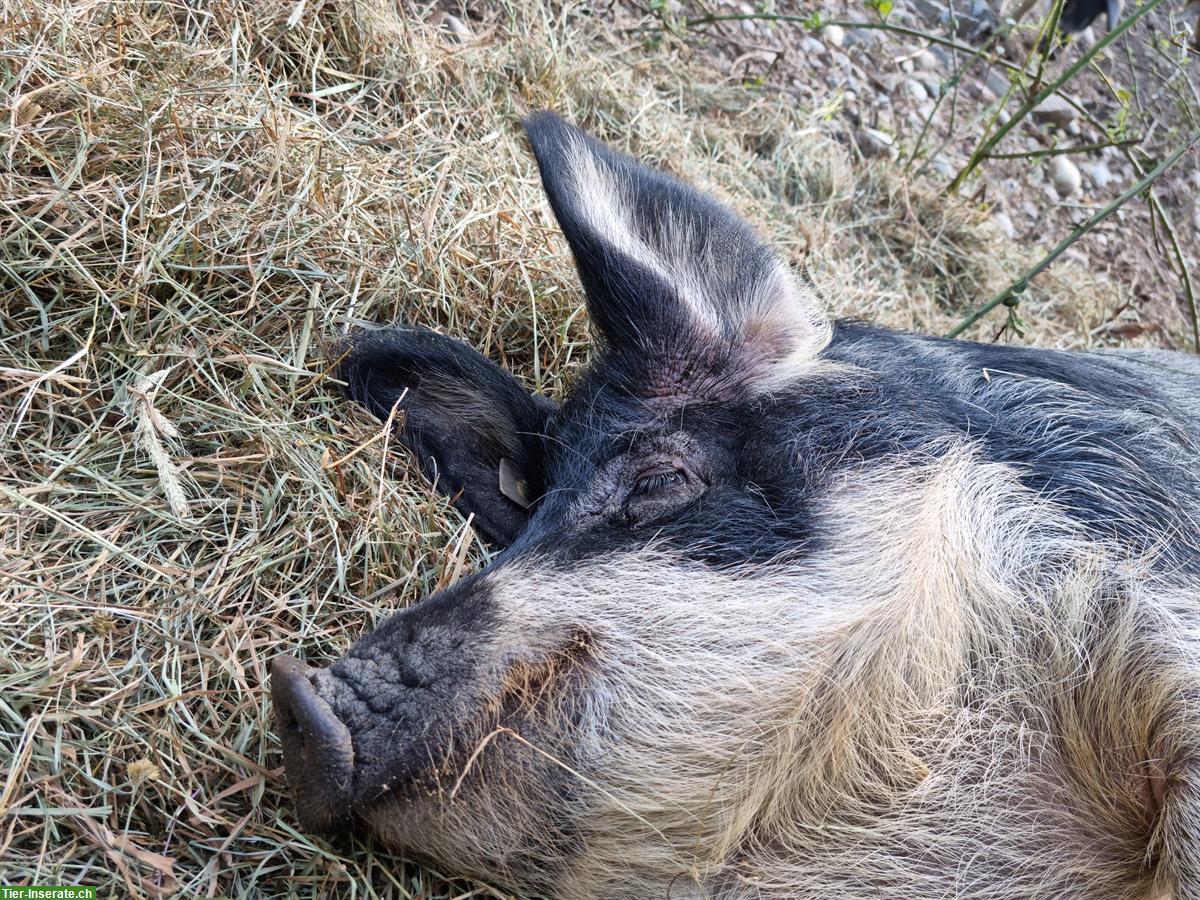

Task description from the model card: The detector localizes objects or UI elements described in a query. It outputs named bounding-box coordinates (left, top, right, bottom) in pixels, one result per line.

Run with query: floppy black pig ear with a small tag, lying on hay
left=337, top=326, right=554, bottom=547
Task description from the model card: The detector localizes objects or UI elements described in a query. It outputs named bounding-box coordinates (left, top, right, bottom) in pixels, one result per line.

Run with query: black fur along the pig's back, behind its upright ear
left=816, top=323, right=1200, bottom=570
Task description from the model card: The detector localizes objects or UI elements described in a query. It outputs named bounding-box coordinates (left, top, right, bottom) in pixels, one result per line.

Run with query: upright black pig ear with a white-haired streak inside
left=526, top=113, right=829, bottom=391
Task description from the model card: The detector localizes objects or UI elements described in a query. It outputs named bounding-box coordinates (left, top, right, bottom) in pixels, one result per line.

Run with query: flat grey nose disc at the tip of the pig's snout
left=271, top=656, right=354, bottom=832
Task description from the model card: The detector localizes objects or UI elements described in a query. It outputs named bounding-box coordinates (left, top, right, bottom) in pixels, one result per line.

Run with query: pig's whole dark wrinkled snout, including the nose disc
left=271, top=583, right=494, bottom=832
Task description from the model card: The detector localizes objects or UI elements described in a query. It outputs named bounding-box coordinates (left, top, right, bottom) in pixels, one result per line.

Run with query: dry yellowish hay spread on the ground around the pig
left=0, top=0, right=1152, bottom=898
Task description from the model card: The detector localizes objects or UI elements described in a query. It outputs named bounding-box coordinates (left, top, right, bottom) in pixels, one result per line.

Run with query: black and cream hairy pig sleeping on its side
left=271, top=113, right=1200, bottom=900
